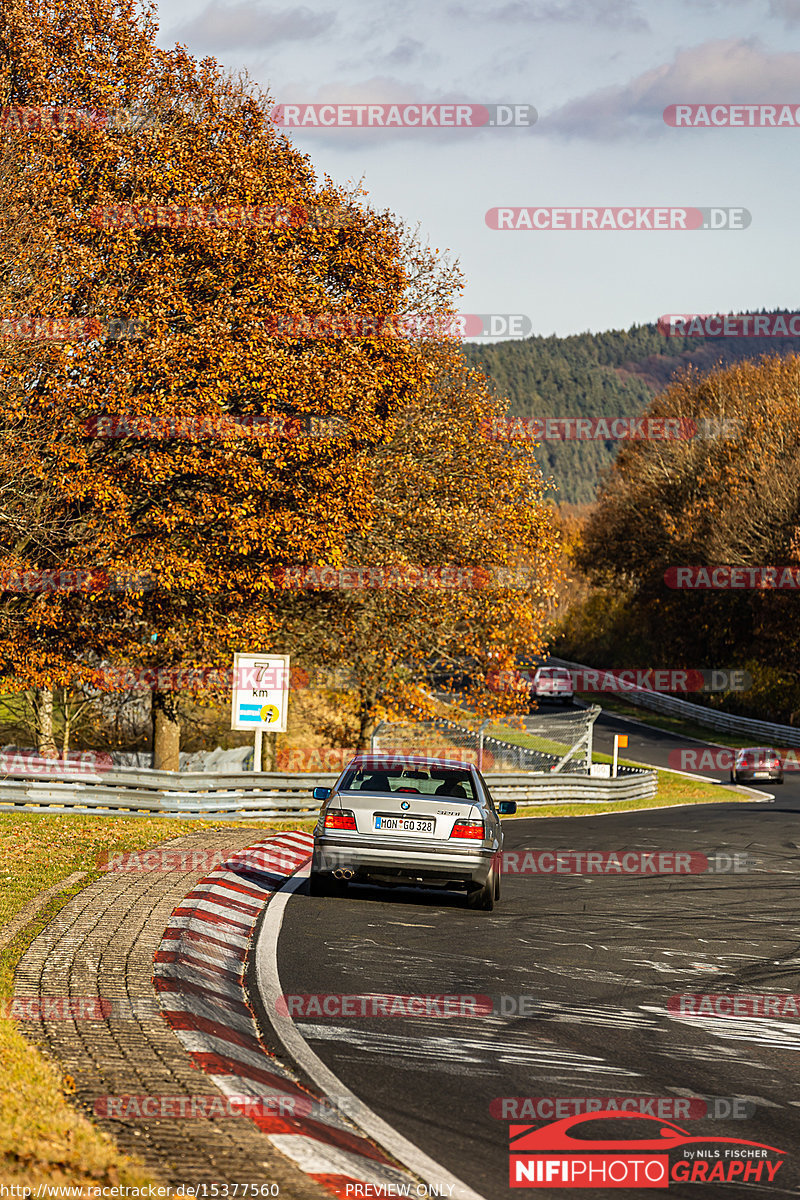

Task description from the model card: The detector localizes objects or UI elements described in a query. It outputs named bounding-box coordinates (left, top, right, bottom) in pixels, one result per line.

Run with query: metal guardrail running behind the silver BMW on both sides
left=0, top=768, right=656, bottom=821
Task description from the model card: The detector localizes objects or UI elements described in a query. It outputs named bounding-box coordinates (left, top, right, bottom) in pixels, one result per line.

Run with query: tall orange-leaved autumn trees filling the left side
left=0, top=0, right=563, bottom=766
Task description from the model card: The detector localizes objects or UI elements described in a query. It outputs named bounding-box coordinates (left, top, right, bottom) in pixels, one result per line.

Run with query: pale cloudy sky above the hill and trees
left=149, top=0, right=800, bottom=336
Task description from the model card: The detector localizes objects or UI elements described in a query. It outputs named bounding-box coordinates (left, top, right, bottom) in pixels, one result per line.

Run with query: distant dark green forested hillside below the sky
left=465, top=324, right=800, bottom=503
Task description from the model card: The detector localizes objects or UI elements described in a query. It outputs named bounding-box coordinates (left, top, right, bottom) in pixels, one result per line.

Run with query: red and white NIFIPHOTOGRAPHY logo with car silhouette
left=509, top=1109, right=786, bottom=1189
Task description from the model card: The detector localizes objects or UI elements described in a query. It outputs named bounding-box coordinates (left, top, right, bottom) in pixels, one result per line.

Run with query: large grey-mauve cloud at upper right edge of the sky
left=539, top=37, right=800, bottom=140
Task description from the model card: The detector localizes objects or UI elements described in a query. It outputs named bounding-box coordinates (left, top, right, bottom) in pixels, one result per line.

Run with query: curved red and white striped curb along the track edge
left=154, top=832, right=417, bottom=1198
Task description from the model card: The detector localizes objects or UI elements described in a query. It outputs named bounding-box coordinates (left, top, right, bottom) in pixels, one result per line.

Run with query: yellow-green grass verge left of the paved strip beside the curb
left=0, top=814, right=313, bottom=1200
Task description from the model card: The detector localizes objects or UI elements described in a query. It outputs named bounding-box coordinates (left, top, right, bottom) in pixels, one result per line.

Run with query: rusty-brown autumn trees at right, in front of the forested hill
left=567, top=356, right=800, bottom=715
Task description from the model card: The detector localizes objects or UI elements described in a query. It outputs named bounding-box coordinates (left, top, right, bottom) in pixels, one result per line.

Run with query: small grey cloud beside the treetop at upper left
left=174, top=0, right=336, bottom=53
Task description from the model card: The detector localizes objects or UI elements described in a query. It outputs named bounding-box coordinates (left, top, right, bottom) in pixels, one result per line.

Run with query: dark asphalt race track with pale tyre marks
left=266, top=718, right=800, bottom=1200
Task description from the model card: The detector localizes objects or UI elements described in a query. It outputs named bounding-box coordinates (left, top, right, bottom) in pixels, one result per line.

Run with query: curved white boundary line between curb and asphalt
left=254, top=868, right=486, bottom=1200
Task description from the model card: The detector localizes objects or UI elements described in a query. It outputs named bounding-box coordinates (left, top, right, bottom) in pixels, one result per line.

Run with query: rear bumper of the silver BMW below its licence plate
left=312, top=836, right=498, bottom=887
